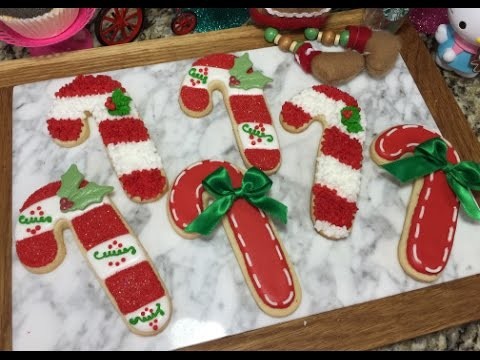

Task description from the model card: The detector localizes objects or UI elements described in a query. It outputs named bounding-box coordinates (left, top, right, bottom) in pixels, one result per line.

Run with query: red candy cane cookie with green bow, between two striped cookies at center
left=168, top=160, right=301, bottom=316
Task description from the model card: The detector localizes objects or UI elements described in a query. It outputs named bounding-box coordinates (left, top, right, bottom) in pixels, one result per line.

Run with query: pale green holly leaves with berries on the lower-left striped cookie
left=57, top=165, right=113, bottom=212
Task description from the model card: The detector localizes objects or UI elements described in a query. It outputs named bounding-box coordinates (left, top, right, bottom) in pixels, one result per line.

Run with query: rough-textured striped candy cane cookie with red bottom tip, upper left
left=47, top=75, right=168, bottom=202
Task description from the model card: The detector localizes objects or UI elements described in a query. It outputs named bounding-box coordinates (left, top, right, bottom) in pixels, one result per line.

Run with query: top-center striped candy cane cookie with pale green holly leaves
left=179, top=54, right=281, bottom=174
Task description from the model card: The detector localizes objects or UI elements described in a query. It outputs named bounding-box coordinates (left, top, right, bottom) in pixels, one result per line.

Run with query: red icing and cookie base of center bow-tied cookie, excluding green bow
left=167, top=160, right=301, bottom=316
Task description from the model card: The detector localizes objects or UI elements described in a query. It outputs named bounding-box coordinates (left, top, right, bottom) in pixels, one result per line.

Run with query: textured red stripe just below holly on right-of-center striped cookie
left=322, top=126, right=363, bottom=170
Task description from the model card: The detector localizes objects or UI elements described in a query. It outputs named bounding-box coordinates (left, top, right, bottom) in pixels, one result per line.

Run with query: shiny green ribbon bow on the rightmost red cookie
left=382, top=137, right=480, bottom=220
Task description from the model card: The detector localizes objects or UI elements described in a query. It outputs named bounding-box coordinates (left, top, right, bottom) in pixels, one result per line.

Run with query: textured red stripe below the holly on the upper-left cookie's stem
left=98, top=118, right=150, bottom=146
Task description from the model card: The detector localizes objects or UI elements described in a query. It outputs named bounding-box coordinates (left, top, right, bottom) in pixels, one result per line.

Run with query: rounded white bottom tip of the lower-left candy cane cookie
left=124, top=296, right=171, bottom=332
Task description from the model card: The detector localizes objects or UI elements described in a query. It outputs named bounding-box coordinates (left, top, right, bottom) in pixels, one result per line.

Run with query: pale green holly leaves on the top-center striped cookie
left=229, top=53, right=272, bottom=90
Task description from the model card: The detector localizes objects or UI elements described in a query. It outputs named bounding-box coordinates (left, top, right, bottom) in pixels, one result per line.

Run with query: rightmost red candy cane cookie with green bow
left=370, top=125, right=474, bottom=282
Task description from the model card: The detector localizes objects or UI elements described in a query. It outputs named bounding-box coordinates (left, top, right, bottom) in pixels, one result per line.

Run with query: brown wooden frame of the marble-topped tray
left=0, top=10, right=480, bottom=350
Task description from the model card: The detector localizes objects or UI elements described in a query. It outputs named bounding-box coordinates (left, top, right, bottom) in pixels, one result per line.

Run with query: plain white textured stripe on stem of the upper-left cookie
left=107, top=140, right=162, bottom=176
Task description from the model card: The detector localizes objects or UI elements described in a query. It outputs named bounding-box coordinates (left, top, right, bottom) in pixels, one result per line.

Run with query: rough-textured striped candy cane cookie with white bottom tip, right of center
left=280, top=85, right=365, bottom=239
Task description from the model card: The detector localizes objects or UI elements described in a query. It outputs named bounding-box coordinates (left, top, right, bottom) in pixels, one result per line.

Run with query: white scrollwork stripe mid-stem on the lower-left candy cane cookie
left=87, top=234, right=147, bottom=280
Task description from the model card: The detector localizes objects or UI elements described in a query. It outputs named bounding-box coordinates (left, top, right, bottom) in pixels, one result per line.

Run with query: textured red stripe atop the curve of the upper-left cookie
left=55, top=75, right=125, bottom=98
